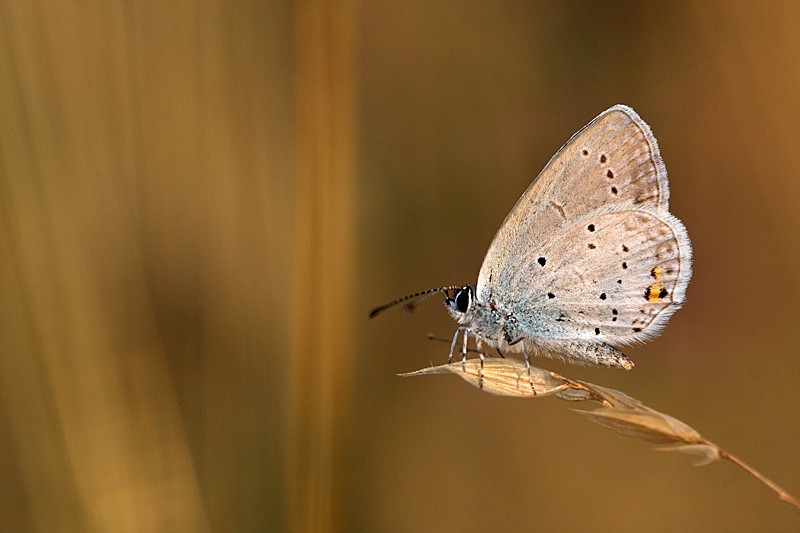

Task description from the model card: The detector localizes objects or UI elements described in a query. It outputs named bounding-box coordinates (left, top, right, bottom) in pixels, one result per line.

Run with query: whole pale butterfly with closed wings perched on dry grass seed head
left=371, top=105, right=692, bottom=384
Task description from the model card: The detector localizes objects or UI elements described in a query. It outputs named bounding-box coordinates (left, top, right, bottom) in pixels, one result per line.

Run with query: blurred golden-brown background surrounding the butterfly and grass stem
left=0, top=0, right=800, bottom=531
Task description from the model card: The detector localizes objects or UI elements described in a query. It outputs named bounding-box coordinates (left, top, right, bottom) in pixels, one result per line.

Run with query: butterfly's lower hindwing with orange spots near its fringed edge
left=504, top=205, right=692, bottom=346
